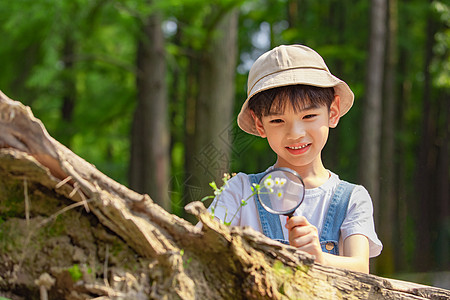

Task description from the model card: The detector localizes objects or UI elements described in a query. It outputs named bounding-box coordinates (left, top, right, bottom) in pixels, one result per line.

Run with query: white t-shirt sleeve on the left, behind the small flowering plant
left=208, top=173, right=248, bottom=226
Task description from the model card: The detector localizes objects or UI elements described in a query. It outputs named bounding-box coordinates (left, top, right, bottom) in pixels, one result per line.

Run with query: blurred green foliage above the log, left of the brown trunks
left=0, top=0, right=137, bottom=183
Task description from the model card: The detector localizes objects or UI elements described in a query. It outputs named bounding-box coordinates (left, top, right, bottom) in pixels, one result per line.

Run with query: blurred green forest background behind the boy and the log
left=0, top=0, right=450, bottom=282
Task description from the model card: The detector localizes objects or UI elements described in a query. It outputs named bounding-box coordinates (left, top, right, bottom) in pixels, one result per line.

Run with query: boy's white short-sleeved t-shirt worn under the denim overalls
left=209, top=168, right=383, bottom=257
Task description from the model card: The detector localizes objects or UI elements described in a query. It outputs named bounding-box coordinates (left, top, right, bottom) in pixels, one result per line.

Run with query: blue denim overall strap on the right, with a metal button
left=319, top=181, right=355, bottom=255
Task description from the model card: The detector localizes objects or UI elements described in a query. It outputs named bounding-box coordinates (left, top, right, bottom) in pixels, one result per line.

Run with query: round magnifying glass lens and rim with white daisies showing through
left=258, top=168, right=305, bottom=218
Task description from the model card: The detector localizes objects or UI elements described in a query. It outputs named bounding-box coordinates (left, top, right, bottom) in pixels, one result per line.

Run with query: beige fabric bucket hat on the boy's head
left=237, top=45, right=354, bottom=136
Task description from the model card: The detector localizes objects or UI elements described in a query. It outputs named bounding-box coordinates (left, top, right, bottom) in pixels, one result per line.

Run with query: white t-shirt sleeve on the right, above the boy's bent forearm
left=341, top=185, right=383, bottom=257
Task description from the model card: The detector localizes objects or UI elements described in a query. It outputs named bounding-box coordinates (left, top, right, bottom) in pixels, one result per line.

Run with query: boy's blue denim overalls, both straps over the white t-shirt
left=248, top=172, right=355, bottom=255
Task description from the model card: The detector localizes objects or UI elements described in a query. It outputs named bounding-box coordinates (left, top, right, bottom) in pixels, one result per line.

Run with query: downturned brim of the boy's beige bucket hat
left=237, top=68, right=354, bottom=136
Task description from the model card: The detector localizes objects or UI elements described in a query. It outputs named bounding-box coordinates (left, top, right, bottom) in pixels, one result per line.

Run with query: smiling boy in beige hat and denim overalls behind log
left=211, top=45, right=382, bottom=273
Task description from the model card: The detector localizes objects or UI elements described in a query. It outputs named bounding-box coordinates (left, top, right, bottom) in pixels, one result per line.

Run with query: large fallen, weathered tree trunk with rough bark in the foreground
left=0, top=92, right=450, bottom=299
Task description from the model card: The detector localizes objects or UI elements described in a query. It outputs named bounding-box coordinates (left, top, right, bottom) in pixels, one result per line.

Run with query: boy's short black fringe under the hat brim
left=248, top=84, right=334, bottom=119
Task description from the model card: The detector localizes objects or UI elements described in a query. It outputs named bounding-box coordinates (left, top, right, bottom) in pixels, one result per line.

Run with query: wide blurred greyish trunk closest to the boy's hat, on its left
left=185, top=9, right=238, bottom=220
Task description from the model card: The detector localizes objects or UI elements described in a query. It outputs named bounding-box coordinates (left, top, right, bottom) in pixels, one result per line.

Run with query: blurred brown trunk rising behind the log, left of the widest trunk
left=130, top=14, right=170, bottom=210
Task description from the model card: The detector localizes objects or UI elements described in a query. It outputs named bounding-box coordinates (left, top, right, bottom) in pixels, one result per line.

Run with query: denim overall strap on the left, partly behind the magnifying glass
left=248, top=172, right=285, bottom=242
